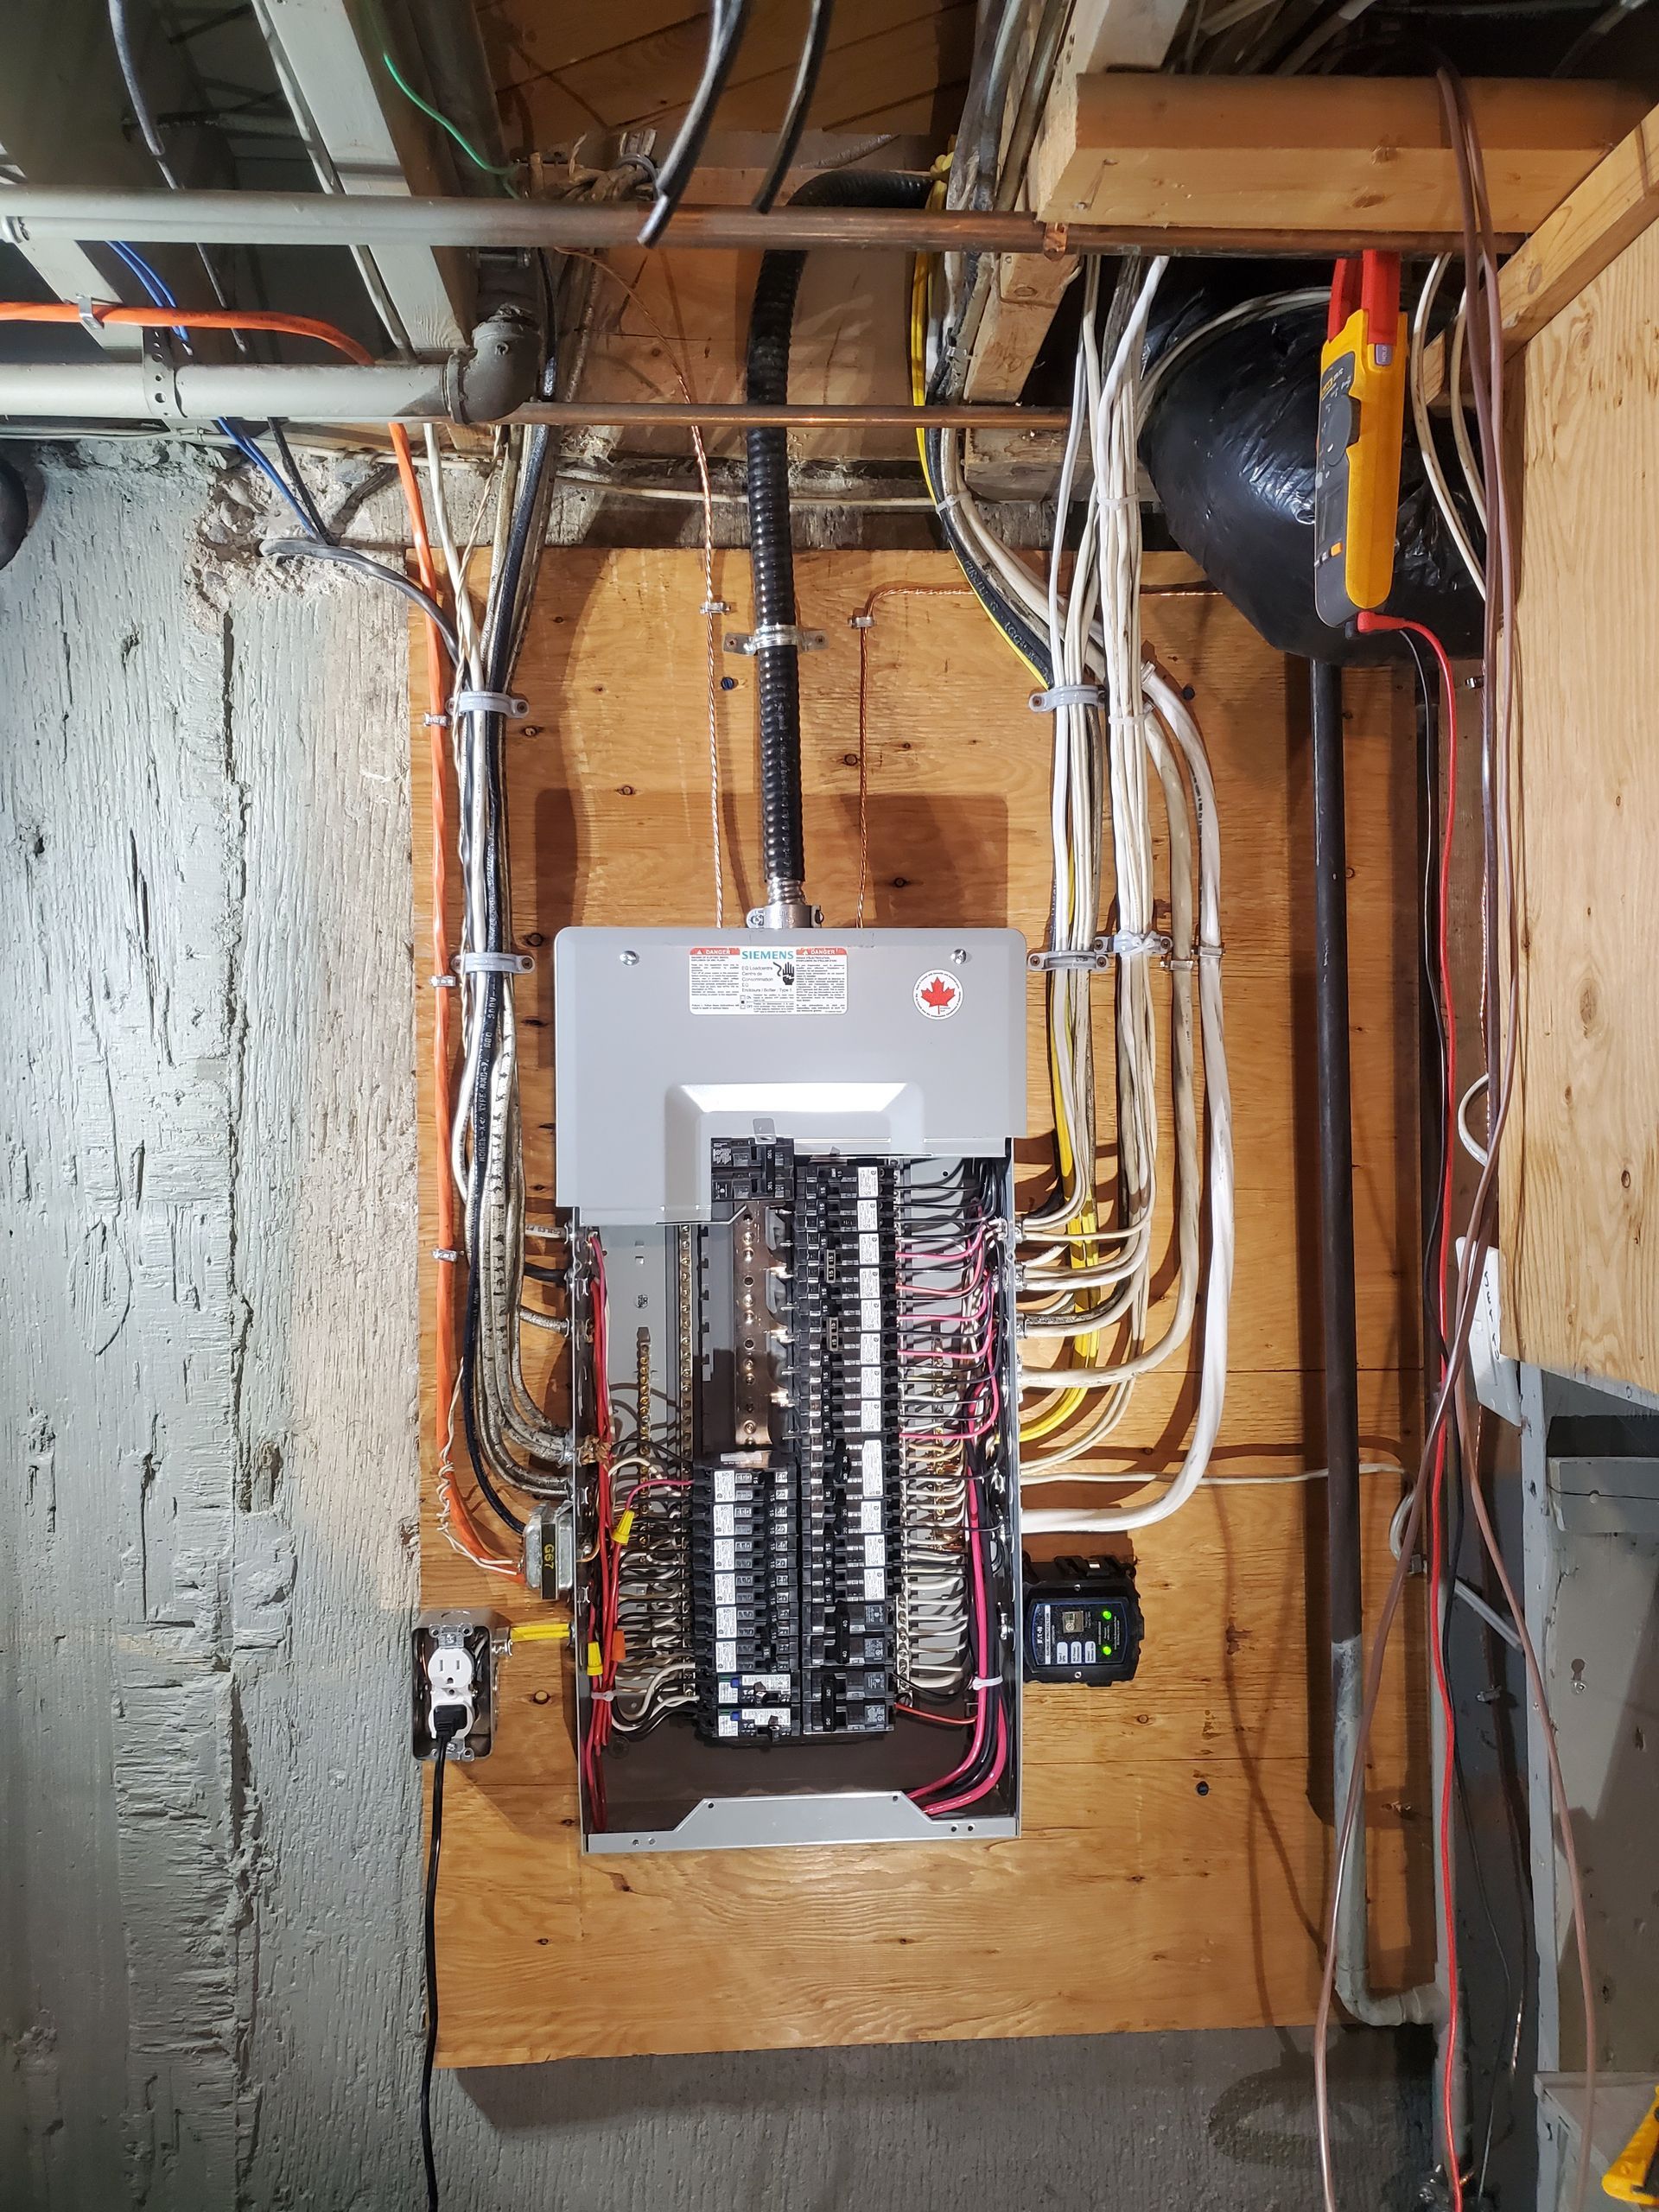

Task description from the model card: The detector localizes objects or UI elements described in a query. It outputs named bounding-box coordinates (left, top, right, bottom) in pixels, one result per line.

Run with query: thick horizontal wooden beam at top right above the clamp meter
left=1031, top=75, right=1646, bottom=245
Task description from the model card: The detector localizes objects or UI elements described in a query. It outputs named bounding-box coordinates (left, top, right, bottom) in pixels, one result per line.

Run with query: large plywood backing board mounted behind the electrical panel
left=416, top=550, right=1429, bottom=2066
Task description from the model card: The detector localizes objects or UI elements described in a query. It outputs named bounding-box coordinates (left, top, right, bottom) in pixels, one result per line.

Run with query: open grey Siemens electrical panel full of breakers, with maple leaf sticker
left=553, top=929, right=1027, bottom=1852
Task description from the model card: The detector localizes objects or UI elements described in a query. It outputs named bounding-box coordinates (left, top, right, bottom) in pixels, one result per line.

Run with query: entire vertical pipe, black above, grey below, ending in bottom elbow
left=1312, top=661, right=1442, bottom=2029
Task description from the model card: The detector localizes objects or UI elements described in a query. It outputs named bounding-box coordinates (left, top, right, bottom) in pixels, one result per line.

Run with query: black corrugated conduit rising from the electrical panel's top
left=746, top=168, right=942, bottom=929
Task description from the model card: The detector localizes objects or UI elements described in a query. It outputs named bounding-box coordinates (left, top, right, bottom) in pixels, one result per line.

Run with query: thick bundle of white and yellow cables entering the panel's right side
left=913, top=259, right=1234, bottom=1531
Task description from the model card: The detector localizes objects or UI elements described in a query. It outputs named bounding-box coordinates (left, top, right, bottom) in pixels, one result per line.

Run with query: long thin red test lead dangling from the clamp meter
left=1358, top=613, right=1478, bottom=2212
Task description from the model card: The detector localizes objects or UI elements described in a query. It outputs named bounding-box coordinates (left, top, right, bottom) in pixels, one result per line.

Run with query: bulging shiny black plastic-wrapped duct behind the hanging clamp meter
left=1141, top=292, right=1482, bottom=664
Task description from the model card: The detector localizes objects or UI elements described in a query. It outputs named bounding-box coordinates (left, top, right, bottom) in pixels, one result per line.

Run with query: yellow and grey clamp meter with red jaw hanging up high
left=1314, top=252, right=1407, bottom=631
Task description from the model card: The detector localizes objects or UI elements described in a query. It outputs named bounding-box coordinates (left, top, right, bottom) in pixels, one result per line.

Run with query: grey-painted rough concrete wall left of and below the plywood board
left=0, top=447, right=1427, bottom=2212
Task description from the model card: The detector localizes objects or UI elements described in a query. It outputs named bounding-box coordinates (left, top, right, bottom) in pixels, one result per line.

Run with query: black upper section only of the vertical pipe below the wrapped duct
left=1312, top=661, right=1360, bottom=1663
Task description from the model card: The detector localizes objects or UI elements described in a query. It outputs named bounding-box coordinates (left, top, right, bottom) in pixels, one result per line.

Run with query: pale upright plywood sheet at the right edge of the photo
left=1502, top=211, right=1659, bottom=1389
